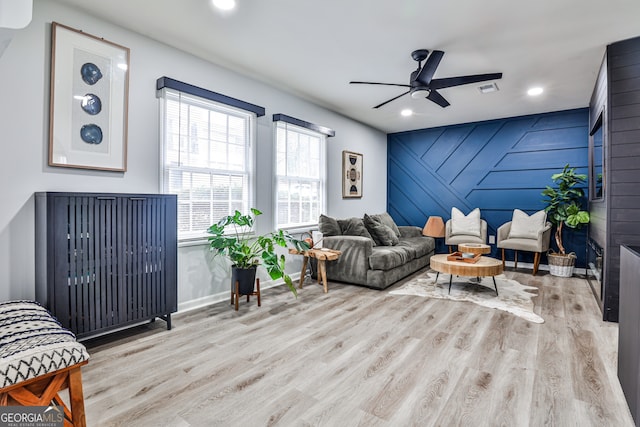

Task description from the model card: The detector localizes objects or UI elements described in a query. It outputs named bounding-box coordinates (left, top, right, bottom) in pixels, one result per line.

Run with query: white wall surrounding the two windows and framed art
left=0, top=1, right=387, bottom=309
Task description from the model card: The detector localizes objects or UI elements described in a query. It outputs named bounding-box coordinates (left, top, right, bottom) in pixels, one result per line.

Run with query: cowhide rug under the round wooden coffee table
left=389, top=272, right=544, bottom=323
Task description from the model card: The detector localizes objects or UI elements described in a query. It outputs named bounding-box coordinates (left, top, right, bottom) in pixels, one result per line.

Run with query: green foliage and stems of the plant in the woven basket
left=542, top=164, right=589, bottom=255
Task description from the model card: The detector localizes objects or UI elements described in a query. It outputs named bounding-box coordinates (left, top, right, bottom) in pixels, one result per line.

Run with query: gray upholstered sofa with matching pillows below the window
left=318, top=213, right=435, bottom=289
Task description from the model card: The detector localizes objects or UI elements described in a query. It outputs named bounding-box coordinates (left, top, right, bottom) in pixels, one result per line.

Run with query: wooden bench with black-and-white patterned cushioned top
left=0, top=301, right=89, bottom=427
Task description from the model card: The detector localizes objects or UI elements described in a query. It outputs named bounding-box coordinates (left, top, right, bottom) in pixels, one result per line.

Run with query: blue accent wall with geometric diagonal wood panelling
left=387, top=108, right=589, bottom=266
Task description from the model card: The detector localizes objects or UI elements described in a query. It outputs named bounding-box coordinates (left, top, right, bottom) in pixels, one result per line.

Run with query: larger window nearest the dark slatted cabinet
left=159, top=80, right=256, bottom=239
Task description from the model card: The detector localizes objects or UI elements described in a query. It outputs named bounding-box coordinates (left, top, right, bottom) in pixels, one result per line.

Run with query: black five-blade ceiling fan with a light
left=349, top=49, right=502, bottom=108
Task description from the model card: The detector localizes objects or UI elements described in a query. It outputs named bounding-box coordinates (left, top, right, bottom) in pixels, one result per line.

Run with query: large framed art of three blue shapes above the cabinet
left=49, top=22, right=129, bottom=172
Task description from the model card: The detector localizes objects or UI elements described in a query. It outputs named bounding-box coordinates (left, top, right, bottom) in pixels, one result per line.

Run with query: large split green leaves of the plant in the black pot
left=207, top=208, right=309, bottom=297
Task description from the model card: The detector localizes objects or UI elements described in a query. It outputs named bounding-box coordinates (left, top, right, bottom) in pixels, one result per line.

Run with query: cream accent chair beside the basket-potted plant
left=496, top=209, right=551, bottom=276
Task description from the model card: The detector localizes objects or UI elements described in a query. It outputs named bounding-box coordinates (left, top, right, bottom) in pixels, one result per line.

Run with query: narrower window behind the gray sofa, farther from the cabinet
left=274, top=115, right=326, bottom=228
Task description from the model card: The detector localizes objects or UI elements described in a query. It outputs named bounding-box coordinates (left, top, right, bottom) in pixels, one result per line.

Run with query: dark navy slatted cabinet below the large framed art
left=36, top=192, right=177, bottom=338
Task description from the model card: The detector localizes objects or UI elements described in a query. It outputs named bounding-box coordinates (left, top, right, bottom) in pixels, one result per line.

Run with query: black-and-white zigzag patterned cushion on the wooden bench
left=0, top=301, right=89, bottom=388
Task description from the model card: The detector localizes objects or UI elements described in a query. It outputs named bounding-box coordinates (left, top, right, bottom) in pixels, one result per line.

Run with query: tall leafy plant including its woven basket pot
left=542, top=164, right=589, bottom=277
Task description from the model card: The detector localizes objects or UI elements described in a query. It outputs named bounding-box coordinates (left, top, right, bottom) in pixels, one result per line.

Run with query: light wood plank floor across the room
left=83, top=271, right=633, bottom=427
